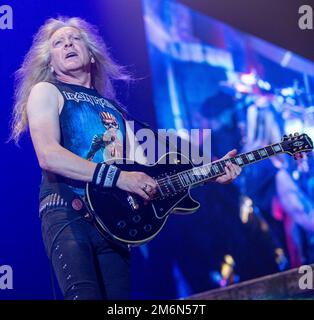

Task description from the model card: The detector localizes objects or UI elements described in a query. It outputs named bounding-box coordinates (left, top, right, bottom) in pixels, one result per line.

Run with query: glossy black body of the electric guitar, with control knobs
left=86, top=152, right=200, bottom=245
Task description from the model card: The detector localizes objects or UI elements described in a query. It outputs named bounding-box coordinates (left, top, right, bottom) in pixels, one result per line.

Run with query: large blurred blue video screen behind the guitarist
left=130, top=0, right=314, bottom=298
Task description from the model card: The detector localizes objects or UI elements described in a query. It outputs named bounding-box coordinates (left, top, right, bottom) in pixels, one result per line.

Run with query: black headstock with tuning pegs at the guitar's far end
left=281, top=133, right=313, bottom=158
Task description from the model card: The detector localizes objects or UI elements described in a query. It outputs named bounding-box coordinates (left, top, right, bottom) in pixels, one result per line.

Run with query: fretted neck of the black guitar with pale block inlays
left=177, top=143, right=284, bottom=188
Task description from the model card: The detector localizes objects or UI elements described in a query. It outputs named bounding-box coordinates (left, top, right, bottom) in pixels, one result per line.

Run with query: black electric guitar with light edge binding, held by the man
left=86, top=134, right=313, bottom=245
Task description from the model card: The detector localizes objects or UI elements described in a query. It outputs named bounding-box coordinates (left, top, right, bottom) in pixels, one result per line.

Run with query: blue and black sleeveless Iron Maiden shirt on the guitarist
left=40, top=81, right=126, bottom=199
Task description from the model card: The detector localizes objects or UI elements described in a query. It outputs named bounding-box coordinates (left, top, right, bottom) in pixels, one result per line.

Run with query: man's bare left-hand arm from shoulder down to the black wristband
left=27, top=82, right=96, bottom=182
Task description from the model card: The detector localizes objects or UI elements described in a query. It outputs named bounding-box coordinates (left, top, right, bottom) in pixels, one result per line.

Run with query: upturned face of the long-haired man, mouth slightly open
left=50, top=27, right=91, bottom=75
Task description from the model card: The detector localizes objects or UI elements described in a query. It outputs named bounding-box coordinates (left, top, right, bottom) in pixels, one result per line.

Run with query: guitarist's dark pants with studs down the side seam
left=40, top=198, right=130, bottom=300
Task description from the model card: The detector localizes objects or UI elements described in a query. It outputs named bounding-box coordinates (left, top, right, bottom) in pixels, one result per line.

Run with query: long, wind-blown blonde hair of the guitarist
left=10, top=17, right=131, bottom=143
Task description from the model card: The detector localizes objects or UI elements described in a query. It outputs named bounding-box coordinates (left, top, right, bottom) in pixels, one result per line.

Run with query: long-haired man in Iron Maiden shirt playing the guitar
left=11, top=18, right=241, bottom=300
